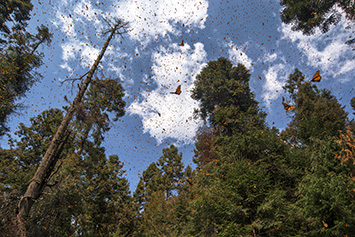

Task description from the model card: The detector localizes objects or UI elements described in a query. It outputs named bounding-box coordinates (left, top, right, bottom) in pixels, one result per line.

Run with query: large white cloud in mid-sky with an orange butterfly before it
left=128, top=43, right=206, bottom=143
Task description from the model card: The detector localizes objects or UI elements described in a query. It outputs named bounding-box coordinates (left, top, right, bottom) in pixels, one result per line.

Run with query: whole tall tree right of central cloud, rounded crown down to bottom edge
left=188, top=58, right=296, bottom=236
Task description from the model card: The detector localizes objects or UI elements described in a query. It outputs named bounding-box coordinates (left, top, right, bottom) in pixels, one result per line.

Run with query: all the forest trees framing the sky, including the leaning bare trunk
left=0, top=0, right=355, bottom=236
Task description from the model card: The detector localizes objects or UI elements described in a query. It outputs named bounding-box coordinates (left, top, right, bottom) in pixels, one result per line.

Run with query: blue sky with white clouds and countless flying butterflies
left=1, top=0, right=355, bottom=191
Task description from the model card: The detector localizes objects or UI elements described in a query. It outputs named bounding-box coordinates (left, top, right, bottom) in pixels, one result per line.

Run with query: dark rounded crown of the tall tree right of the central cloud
left=192, top=58, right=257, bottom=125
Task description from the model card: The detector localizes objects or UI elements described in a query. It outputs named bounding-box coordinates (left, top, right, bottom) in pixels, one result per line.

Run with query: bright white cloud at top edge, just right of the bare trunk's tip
left=112, top=0, right=208, bottom=41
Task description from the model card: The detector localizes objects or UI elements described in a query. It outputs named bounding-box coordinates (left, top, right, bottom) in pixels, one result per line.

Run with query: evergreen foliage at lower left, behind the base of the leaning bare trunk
left=0, top=109, right=134, bottom=236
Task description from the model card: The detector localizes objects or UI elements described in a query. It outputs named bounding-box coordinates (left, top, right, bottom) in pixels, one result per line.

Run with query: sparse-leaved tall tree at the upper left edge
left=0, top=0, right=52, bottom=136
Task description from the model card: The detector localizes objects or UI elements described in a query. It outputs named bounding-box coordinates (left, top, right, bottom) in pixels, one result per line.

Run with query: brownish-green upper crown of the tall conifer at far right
left=284, top=69, right=351, bottom=145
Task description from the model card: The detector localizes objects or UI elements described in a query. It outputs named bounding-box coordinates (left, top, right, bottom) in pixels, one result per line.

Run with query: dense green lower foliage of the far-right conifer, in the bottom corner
left=296, top=139, right=355, bottom=236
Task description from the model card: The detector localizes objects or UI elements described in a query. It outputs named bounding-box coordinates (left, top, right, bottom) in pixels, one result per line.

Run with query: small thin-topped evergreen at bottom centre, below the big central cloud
left=134, top=145, right=189, bottom=236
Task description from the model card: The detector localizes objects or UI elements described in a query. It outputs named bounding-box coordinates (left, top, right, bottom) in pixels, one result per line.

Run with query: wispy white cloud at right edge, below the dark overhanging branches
left=280, top=4, right=355, bottom=78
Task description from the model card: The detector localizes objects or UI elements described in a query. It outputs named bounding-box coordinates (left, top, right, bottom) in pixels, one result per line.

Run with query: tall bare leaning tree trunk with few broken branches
left=17, top=22, right=121, bottom=236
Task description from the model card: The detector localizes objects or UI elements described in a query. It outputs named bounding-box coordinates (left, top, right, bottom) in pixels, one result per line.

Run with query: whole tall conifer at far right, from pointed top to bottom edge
left=282, top=69, right=354, bottom=236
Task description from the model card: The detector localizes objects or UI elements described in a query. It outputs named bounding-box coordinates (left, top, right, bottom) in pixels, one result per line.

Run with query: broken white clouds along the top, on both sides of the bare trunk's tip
left=52, top=0, right=208, bottom=71
